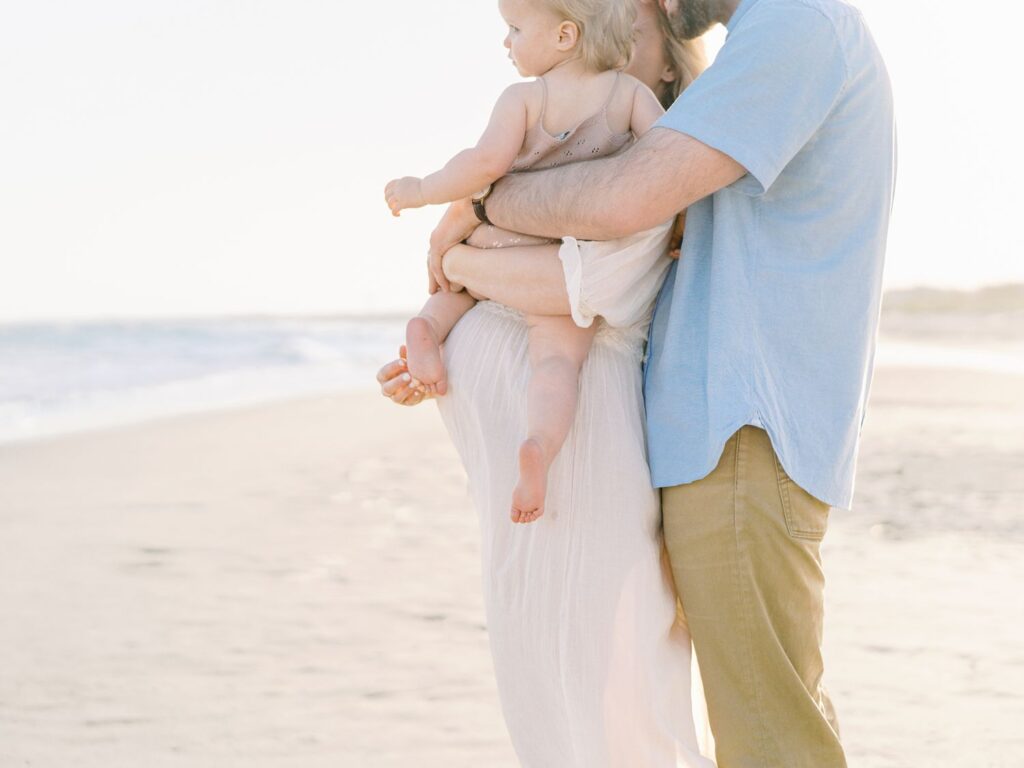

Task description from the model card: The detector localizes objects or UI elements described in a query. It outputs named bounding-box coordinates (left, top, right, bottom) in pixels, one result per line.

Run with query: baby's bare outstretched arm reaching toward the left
left=384, top=83, right=536, bottom=216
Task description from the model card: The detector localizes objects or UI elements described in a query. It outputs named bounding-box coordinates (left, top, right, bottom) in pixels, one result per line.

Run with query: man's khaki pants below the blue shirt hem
left=662, top=427, right=846, bottom=768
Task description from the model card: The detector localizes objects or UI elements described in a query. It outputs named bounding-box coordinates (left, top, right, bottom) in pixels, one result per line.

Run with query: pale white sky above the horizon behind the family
left=0, top=0, right=1024, bottom=321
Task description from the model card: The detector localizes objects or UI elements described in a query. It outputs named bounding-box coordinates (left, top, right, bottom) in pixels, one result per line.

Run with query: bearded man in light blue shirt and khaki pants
left=385, top=0, right=895, bottom=768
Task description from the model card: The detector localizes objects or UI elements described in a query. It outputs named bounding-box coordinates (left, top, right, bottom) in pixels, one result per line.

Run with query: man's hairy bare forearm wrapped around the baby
left=486, top=128, right=746, bottom=240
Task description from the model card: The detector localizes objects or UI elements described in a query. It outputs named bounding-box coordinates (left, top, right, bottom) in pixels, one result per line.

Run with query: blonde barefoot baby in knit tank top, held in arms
left=385, top=0, right=664, bottom=522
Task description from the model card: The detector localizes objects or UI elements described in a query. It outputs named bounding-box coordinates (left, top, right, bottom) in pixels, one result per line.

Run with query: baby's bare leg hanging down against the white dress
left=512, top=315, right=596, bottom=522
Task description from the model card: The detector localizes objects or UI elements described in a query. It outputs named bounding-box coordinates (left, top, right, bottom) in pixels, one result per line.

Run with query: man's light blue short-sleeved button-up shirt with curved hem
left=644, top=0, right=895, bottom=509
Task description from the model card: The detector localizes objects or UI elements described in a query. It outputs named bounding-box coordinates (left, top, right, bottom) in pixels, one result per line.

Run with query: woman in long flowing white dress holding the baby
left=378, top=2, right=712, bottom=768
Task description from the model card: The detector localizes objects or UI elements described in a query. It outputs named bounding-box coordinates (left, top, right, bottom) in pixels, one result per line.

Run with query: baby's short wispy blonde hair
left=542, top=0, right=637, bottom=72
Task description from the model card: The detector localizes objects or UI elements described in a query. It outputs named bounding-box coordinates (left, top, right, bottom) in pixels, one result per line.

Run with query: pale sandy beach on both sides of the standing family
left=0, top=367, right=1024, bottom=768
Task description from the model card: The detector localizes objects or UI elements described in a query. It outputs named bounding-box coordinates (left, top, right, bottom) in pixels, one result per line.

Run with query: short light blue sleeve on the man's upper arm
left=657, top=1, right=848, bottom=195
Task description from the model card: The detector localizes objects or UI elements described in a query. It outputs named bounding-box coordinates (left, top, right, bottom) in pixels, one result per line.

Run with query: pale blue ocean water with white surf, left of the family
left=0, top=317, right=404, bottom=442
